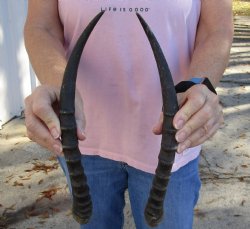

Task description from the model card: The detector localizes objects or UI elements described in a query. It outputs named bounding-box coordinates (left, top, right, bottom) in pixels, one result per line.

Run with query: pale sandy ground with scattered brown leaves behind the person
left=0, top=17, right=250, bottom=229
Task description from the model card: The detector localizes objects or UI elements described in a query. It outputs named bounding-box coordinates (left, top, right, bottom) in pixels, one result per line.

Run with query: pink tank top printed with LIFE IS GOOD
left=58, top=0, right=200, bottom=173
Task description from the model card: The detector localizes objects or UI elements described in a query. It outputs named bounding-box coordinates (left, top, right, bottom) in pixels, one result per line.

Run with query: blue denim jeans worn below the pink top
left=59, top=156, right=201, bottom=229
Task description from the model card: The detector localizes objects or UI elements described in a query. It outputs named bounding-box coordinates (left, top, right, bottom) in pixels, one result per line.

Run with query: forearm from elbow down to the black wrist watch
left=188, top=30, right=232, bottom=87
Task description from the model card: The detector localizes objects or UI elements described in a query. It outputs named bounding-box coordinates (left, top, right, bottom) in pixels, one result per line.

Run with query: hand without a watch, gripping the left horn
left=25, top=85, right=85, bottom=156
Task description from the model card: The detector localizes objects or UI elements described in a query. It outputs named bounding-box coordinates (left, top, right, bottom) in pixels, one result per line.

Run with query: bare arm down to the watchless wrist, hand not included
left=24, top=0, right=66, bottom=86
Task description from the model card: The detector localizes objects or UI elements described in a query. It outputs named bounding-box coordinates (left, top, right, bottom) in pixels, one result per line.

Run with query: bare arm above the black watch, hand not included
left=189, top=0, right=233, bottom=86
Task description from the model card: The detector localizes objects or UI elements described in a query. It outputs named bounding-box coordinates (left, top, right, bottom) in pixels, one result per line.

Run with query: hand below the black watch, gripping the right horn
left=153, top=84, right=224, bottom=153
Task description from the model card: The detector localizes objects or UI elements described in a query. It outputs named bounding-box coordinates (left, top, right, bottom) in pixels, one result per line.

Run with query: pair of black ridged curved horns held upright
left=60, top=11, right=179, bottom=227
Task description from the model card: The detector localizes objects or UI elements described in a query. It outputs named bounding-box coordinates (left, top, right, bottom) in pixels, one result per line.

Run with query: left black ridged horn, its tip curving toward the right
left=59, top=11, right=104, bottom=224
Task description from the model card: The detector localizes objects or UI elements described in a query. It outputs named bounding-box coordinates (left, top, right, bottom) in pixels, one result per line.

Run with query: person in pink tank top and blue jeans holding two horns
left=24, top=0, right=233, bottom=229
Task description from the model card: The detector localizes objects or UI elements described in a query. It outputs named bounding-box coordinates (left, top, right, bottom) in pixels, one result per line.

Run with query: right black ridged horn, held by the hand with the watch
left=137, top=13, right=179, bottom=227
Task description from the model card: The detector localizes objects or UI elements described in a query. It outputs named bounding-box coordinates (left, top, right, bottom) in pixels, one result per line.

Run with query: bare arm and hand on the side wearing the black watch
left=153, top=0, right=233, bottom=152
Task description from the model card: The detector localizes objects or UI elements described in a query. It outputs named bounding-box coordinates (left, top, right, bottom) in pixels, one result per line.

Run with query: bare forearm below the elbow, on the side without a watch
left=24, top=26, right=66, bottom=86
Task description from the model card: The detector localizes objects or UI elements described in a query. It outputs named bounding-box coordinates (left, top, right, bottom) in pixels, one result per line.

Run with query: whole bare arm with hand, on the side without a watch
left=24, top=0, right=85, bottom=155
